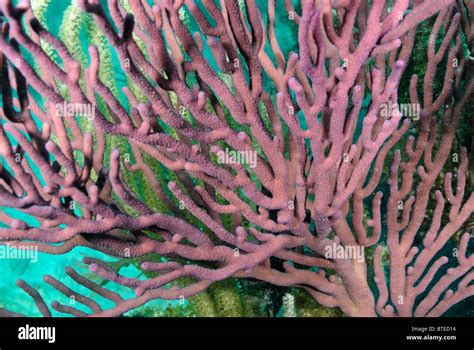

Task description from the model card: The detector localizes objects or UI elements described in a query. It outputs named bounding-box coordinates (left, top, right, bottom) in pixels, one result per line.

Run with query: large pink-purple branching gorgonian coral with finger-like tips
left=0, top=0, right=474, bottom=316
